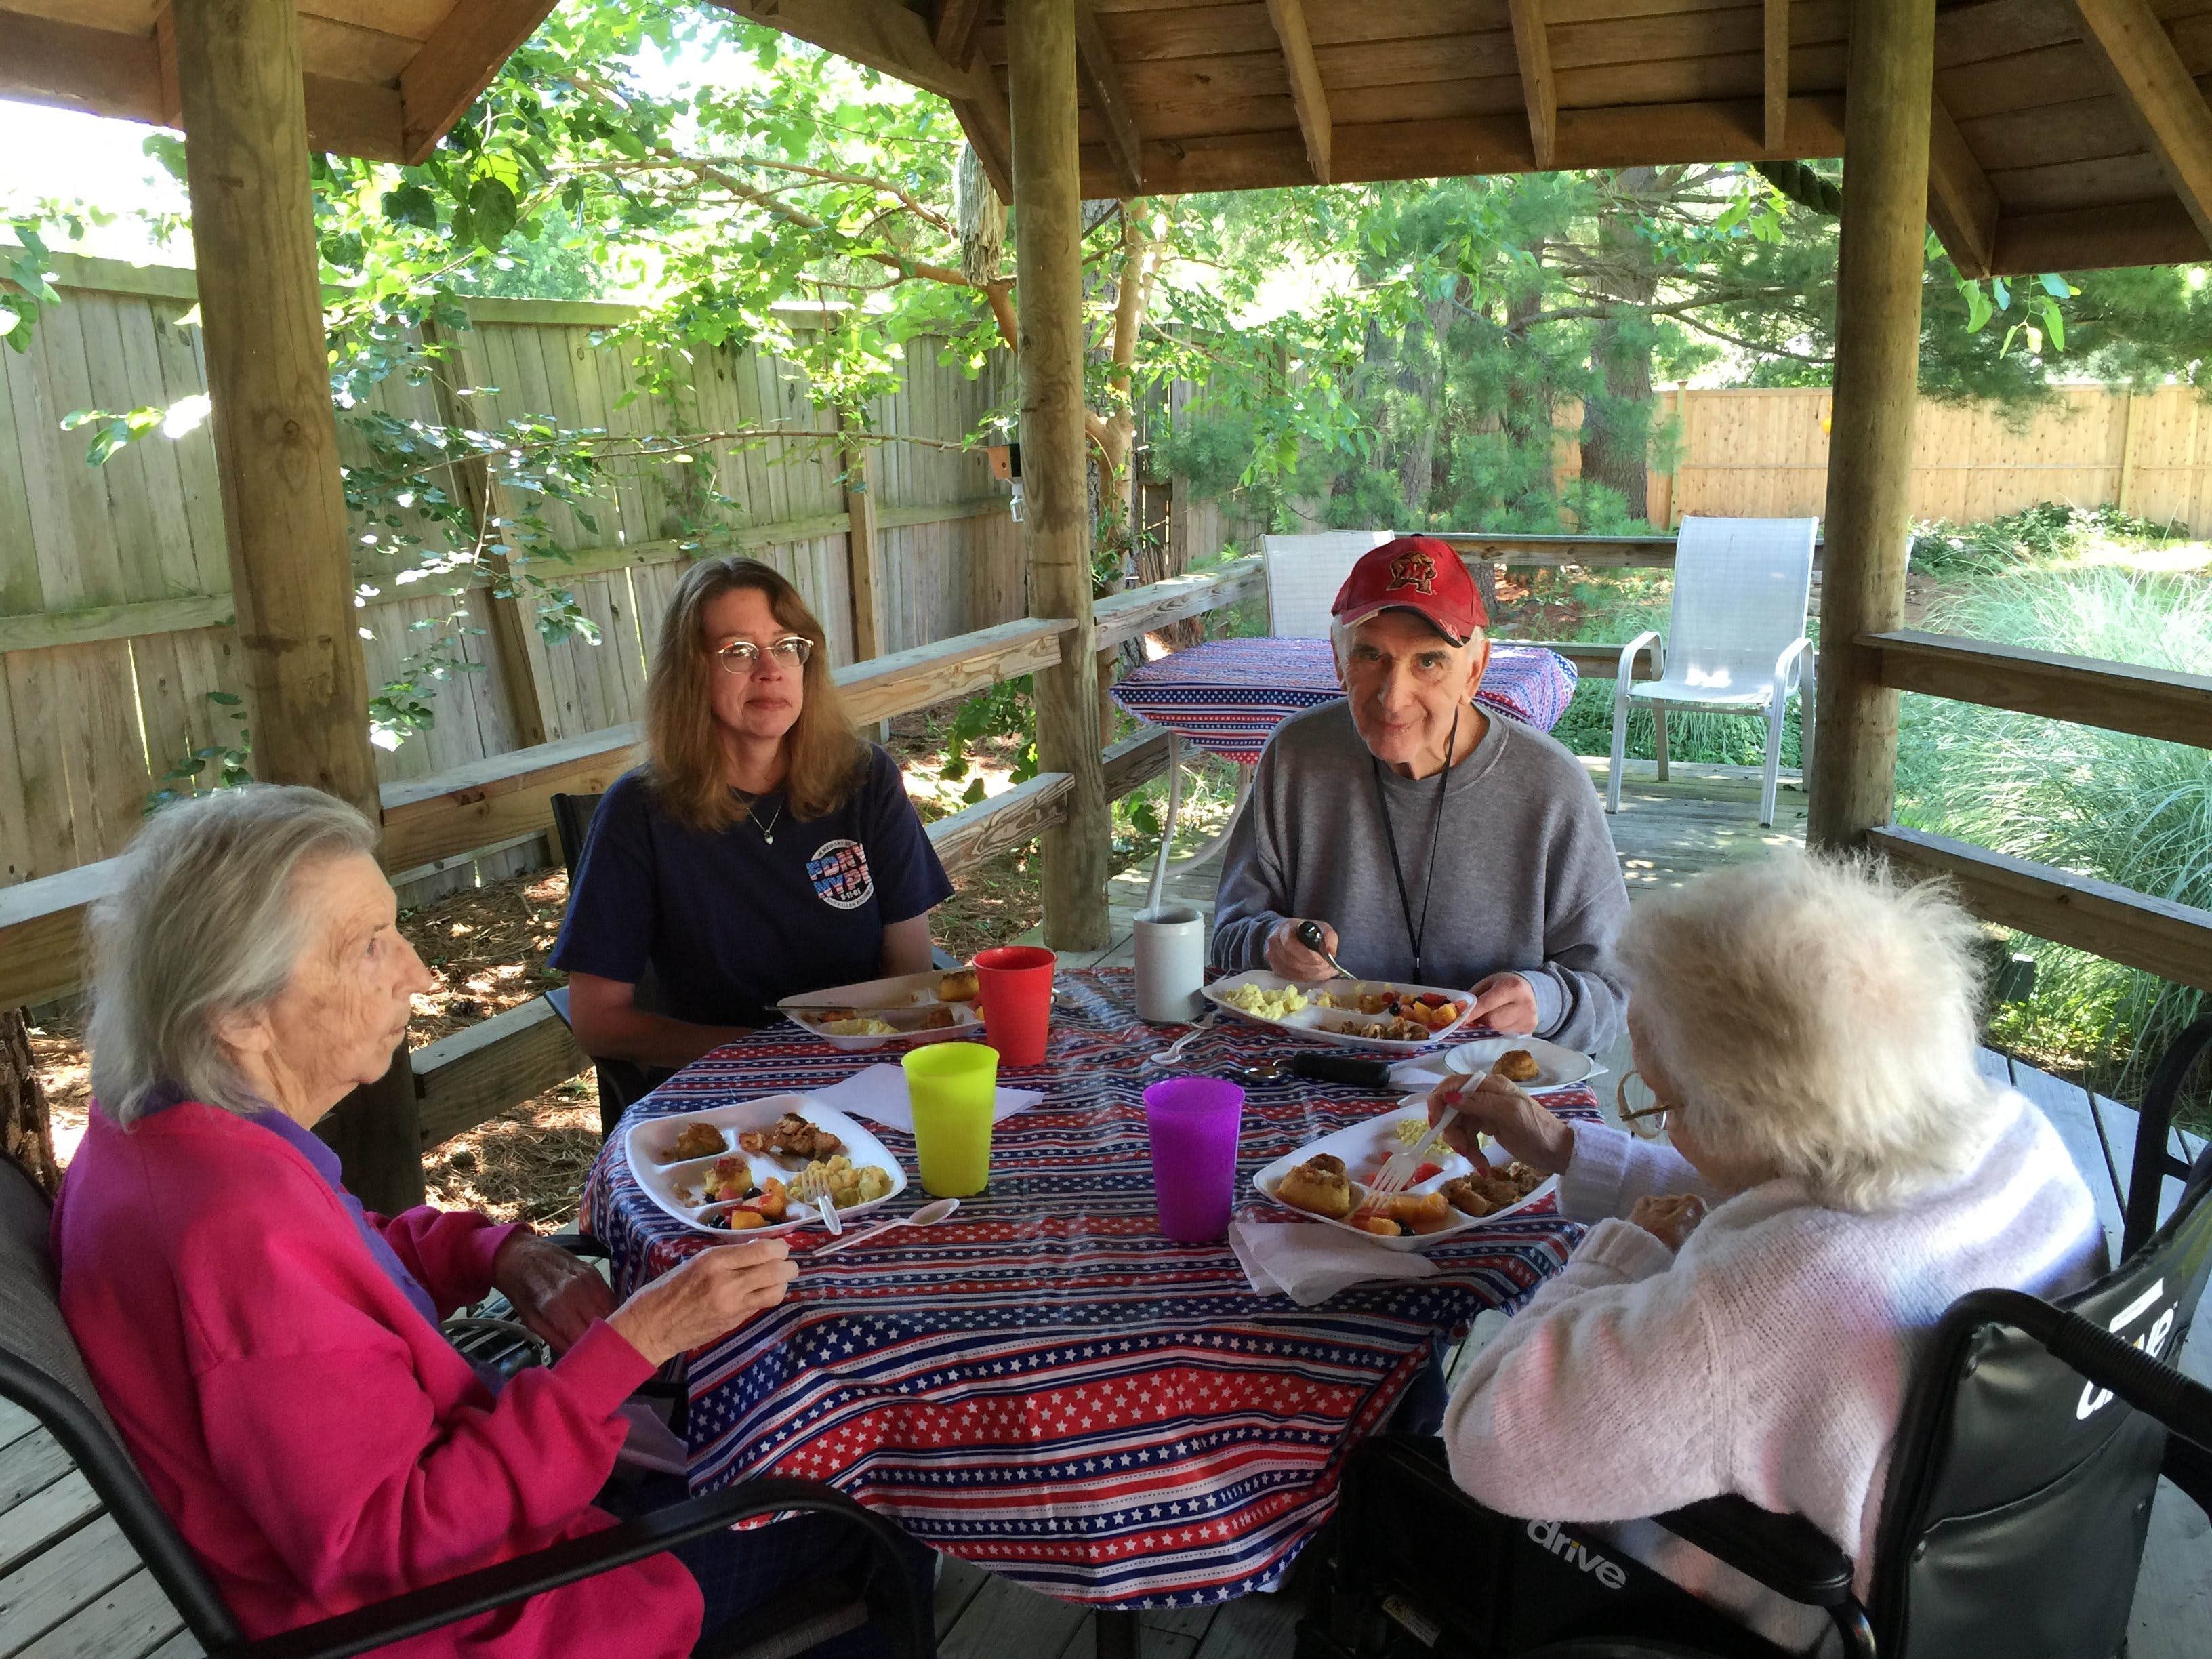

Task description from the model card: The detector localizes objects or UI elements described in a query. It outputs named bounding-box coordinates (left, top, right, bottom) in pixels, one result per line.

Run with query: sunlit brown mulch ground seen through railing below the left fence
left=31, top=705, right=1040, bottom=1228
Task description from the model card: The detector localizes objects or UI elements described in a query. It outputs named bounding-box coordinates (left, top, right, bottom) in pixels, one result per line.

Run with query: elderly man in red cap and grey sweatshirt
left=1212, top=535, right=1628, bottom=1050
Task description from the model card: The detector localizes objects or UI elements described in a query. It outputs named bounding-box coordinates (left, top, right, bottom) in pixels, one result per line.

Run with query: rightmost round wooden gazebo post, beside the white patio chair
left=1805, top=0, right=1936, bottom=847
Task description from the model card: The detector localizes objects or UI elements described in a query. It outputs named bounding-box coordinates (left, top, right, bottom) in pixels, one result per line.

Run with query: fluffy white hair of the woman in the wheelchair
left=1619, top=849, right=1997, bottom=1212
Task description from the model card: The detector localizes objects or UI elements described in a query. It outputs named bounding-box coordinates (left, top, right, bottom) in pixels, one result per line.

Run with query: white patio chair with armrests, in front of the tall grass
left=1606, top=518, right=1820, bottom=823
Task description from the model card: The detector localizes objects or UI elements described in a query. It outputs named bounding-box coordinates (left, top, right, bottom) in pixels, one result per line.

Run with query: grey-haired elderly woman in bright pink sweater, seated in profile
left=53, top=785, right=928, bottom=1659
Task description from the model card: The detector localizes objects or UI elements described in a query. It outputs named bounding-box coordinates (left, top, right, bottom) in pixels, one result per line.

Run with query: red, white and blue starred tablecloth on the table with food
left=584, top=969, right=1597, bottom=1608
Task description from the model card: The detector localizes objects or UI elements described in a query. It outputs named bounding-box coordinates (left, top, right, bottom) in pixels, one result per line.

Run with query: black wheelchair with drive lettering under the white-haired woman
left=1296, top=1020, right=2212, bottom=1659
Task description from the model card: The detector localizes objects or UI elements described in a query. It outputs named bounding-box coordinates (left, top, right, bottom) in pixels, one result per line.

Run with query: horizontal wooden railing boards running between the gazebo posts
left=0, top=535, right=2212, bottom=1146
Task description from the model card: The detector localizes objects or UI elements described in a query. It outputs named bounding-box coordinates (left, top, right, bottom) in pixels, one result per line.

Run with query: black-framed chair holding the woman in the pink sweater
left=0, top=1159, right=933, bottom=1659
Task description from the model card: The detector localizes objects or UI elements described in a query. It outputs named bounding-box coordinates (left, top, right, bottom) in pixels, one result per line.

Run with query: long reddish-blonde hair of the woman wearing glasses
left=646, top=558, right=867, bottom=832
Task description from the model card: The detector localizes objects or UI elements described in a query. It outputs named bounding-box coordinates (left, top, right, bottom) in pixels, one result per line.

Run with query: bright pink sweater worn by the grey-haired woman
left=53, top=1101, right=701, bottom=1659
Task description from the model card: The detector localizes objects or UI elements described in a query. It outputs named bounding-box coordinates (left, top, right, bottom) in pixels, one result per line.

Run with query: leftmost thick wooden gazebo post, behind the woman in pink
left=173, top=0, right=422, bottom=1210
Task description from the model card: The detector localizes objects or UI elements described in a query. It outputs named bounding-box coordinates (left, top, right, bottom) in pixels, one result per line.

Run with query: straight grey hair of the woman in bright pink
left=86, top=783, right=376, bottom=1126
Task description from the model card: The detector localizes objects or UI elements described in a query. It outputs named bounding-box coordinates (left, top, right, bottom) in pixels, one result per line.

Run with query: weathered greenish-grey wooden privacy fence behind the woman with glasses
left=0, top=257, right=1029, bottom=900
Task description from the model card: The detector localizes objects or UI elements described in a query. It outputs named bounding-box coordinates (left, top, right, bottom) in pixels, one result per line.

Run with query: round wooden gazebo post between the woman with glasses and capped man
left=1006, top=0, right=1113, bottom=951
